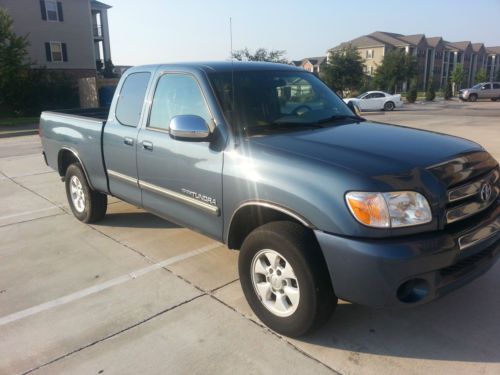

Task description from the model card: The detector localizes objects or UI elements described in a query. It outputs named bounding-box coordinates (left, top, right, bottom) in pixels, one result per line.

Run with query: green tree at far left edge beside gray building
left=0, top=8, right=30, bottom=109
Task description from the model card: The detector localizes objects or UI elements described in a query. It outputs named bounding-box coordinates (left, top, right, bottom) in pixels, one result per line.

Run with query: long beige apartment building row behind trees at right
left=328, top=31, right=500, bottom=90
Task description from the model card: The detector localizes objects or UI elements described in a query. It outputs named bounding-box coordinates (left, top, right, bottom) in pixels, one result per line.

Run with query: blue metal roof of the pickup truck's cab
left=128, top=61, right=304, bottom=73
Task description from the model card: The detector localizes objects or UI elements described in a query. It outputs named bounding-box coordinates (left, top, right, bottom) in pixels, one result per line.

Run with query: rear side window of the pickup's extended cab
left=116, top=72, right=151, bottom=126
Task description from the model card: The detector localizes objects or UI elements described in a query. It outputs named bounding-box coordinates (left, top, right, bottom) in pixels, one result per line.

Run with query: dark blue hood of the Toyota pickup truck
left=248, top=121, right=484, bottom=177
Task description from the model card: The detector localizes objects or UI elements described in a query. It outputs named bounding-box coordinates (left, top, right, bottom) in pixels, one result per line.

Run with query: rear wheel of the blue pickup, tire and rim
left=64, top=163, right=108, bottom=223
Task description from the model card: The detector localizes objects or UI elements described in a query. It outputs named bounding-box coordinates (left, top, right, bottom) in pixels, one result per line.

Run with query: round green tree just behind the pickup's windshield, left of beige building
left=321, top=47, right=364, bottom=92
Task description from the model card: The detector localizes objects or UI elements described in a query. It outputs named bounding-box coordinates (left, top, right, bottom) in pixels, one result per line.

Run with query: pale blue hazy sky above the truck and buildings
left=102, top=0, right=500, bottom=65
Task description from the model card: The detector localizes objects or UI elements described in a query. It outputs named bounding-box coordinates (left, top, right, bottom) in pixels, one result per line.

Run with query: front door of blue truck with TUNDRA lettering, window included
left=137, top=72, right=223, bottom=238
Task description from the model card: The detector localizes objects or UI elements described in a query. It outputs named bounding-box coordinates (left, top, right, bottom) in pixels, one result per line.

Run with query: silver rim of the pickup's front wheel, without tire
left=251, top=249, right=300, bottom=317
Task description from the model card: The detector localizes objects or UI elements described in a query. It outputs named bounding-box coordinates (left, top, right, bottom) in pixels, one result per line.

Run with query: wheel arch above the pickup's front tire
left=226, top=201, right=315, bottom=249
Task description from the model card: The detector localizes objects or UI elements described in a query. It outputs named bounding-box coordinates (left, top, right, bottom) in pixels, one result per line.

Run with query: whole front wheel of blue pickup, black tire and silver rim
left=238, top=221, right=338, bottom=337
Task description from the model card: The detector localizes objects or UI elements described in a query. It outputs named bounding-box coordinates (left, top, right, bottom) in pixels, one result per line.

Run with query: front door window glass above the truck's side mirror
left=148, top=74, right=212, bottom=130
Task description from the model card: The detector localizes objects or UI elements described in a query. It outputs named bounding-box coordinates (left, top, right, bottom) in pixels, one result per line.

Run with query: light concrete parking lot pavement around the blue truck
left=0, top=101, right=500, bottom=374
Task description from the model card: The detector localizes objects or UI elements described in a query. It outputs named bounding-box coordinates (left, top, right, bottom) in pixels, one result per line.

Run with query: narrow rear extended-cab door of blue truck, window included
left=103, top=71, right=151, bottom=206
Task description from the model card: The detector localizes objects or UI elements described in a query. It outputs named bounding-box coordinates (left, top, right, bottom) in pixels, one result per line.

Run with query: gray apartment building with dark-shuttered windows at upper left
left=0, top=0, right=111, bottom=77
